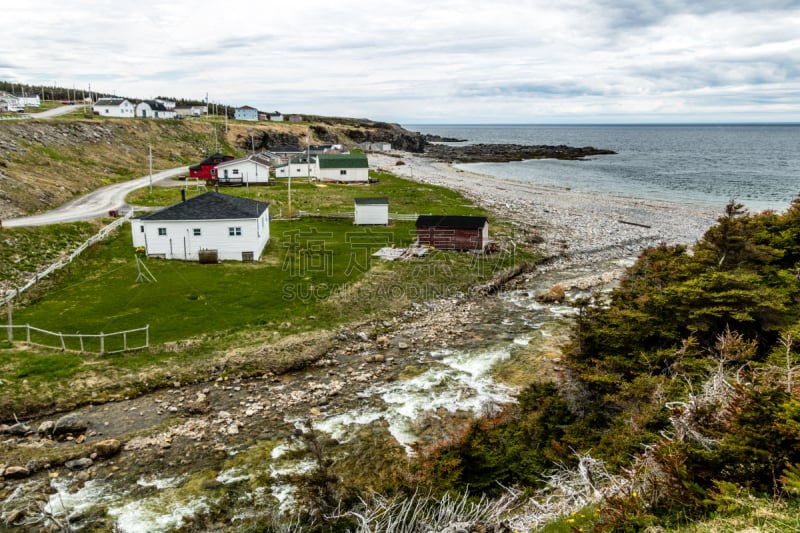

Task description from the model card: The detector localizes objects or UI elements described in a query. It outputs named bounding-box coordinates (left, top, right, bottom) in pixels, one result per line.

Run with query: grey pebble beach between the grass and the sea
left=369, top=153, right=725, bottom=268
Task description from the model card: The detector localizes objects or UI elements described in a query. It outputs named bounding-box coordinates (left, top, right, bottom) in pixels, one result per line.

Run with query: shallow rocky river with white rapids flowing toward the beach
left=2, top=252, right=632, bottom=533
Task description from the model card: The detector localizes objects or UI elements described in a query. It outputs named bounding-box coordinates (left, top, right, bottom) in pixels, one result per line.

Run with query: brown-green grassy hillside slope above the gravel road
left=0, top=116, right=424, bottom=220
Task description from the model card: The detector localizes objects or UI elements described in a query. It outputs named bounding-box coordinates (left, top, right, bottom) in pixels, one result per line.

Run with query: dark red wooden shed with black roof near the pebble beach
left=416, top=215, right=489, bottom=250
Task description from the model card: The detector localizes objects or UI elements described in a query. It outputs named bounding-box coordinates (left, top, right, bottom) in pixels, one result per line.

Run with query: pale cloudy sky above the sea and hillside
left=0, top=0, right=800, bottom=124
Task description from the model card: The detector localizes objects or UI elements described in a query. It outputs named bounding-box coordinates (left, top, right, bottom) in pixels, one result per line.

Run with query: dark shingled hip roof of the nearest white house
left=141, top=192, right=269, bottom=220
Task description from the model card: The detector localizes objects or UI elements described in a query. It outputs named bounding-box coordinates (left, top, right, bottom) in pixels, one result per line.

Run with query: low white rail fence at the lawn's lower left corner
left=0, top=324, right=150, bottom=354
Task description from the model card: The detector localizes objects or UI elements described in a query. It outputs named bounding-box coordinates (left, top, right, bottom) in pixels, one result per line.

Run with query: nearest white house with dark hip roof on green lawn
left=131, top=192, right=269, bottom=261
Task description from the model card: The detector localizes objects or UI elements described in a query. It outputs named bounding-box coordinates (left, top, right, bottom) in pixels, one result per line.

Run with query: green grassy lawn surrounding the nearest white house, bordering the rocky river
left=0, top=170, right=530, bottom=419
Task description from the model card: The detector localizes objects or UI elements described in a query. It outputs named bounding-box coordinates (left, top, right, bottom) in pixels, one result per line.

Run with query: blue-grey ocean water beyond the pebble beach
left=404, top=124, right=800, bottom=213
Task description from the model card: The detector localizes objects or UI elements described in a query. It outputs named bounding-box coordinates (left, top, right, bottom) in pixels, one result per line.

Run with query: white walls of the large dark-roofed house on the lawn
left=131, top=209, right=269, bottom=261
